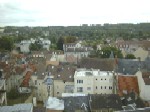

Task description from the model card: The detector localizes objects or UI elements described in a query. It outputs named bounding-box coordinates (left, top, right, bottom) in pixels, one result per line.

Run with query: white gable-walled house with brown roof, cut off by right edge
left=136, top=71, right=150, bottom=101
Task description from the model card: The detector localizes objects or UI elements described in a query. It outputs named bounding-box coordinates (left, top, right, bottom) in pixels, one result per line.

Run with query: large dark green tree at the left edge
left=0, top=37, right=13, bottom=51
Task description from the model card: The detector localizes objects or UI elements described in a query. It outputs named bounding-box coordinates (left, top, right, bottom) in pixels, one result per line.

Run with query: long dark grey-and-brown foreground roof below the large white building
left=63, top=94, right=122, bottom=112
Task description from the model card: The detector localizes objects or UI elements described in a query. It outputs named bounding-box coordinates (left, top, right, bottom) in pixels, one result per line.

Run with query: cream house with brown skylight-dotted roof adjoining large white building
left=47, top=65, right=76, bottom=97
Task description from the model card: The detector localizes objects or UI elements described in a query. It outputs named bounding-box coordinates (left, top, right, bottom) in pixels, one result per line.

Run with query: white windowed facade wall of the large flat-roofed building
left=74, top=71, right=113, bottom=94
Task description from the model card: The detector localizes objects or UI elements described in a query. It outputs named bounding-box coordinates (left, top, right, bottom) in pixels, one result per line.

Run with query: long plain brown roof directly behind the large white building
left=78, top=58, right=115, bottom=71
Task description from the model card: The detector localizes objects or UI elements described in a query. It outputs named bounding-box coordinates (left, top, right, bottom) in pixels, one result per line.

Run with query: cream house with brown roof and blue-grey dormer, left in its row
left=31, top=64, right=53, bottom=102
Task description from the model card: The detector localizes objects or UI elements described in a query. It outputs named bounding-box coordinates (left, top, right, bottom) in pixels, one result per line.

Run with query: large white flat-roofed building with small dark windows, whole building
left=74, top=69, right=113, bottom=94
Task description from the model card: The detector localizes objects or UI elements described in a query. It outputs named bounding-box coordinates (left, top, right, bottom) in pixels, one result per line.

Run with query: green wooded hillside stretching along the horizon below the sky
left=4, top=23, right=150, bottom=43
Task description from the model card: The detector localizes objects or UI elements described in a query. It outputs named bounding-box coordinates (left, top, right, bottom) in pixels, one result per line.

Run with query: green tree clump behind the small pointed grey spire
left=97, top=47, right=123, bottom=58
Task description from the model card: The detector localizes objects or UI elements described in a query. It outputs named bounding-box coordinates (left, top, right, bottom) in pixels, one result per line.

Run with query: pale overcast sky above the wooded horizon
left=0, top=0, right=150, bottom=26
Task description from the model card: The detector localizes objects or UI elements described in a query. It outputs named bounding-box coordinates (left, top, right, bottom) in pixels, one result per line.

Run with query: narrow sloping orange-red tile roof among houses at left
left=21, top=71, right=32, bottom=87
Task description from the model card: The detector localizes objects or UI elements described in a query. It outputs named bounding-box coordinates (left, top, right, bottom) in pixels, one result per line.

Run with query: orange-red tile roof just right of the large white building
left=118, top=75, right=139, bottom=96
